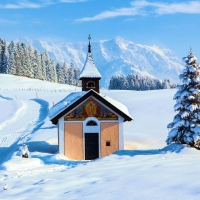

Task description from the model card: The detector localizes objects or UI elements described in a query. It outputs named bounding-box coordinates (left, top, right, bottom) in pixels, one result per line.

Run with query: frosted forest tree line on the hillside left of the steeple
left=0, top=38, right=81, bottom=86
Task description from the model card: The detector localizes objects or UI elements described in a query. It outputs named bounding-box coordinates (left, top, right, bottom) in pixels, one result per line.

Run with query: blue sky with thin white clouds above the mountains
left=0, top=0, right=200, bottom=61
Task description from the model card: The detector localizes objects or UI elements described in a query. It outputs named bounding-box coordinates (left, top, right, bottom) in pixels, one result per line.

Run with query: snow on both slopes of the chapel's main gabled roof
left=49, top=90, right=132, bottom=120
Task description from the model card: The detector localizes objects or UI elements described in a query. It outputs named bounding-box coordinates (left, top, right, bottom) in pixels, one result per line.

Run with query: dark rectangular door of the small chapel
left=85, top=133, right=99, bottom=160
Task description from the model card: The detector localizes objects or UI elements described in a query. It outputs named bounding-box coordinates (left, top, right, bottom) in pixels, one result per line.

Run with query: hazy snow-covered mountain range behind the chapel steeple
left=20, top=37, right=183, bottom=88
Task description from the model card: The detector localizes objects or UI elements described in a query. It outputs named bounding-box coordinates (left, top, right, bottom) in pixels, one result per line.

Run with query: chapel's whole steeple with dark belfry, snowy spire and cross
left=79, top=34, right=101, bottom=93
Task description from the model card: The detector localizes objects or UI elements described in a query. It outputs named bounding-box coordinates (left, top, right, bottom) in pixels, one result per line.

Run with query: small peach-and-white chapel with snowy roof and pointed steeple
left=49, top=35, right=133, bottom=160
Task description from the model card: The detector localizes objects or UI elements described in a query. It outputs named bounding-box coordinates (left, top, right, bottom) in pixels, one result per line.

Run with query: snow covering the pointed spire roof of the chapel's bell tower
left=79, top=52, right=101, bottom=79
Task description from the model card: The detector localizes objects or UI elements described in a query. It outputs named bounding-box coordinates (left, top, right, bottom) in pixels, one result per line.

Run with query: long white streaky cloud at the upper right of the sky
left=76, top=0, right=200, bottom=22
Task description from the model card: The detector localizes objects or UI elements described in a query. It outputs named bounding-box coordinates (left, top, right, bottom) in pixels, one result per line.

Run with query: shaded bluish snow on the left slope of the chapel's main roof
left=49, top=91, right=88, bottom=119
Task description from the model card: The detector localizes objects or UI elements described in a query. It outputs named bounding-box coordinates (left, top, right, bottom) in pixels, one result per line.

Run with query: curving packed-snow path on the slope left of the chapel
left=0, top=99, right=48, bottom=164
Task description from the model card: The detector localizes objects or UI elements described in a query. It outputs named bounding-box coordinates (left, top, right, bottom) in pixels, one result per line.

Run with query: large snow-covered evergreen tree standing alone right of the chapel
left=166, top=49, right=200, bottom=146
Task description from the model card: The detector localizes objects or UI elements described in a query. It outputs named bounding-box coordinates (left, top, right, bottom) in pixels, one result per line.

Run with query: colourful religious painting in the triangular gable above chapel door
left=64, top=97, right=118, bottom=121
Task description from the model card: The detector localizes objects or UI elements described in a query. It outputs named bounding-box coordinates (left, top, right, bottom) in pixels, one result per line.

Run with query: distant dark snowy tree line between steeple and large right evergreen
left=109, top=73, right=176, bottom=90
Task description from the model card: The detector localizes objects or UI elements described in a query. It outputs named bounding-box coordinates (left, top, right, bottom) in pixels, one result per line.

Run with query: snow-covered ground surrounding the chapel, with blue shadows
left=0, top=74, right=200, bottom=200
